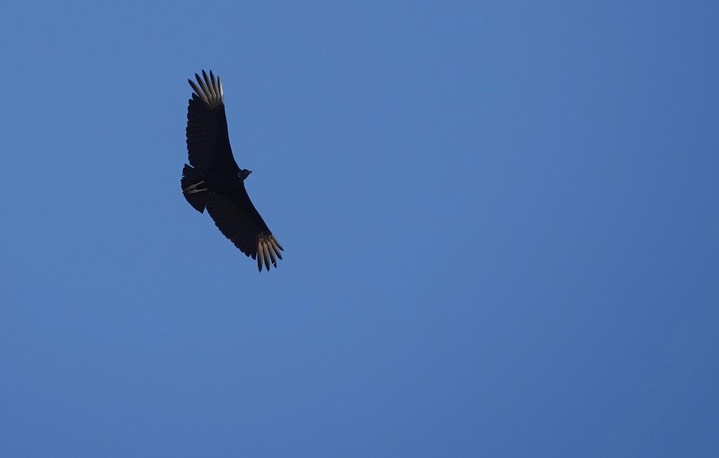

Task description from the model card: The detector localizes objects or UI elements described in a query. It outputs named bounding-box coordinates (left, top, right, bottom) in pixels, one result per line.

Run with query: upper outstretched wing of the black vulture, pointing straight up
left=186, top=70, right=239, bottom=173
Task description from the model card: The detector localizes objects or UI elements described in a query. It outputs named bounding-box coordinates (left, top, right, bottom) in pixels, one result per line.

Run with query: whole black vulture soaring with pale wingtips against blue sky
left=181, top=70, right=284, bottom=272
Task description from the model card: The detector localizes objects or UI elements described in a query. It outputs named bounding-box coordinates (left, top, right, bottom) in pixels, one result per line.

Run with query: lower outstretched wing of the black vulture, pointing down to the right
left=207, top=190, right=284, bottom=271
